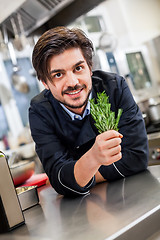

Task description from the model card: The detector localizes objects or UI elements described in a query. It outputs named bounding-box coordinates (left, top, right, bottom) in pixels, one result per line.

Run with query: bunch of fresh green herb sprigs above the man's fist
left=90, top=91, right=123, bottom=133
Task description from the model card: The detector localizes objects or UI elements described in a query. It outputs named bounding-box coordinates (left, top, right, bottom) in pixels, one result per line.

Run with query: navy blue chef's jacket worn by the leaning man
left=29, top=71, right=148, bottom=195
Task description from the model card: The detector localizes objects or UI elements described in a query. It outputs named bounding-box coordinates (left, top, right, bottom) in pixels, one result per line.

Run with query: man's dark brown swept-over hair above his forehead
left=32, top=27, right=93, bottom=82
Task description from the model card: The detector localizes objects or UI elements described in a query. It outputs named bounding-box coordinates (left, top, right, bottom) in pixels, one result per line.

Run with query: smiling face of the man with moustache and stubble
left=43, top=48, right=92, bottom=114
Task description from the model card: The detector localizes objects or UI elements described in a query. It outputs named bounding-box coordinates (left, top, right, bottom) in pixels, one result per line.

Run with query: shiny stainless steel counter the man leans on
left=0, top=166, right=160, bottom=240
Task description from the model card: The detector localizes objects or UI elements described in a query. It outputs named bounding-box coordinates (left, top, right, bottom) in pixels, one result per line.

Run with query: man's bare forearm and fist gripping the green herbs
left=74, top=130, right=123, bottom=187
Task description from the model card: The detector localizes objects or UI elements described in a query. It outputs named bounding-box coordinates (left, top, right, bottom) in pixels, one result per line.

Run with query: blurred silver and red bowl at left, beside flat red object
left=10, top=160, right=35, bottom=186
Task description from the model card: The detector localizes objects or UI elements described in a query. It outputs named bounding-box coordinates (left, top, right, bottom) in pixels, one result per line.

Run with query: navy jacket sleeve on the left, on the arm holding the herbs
left=29, top=102, right=95, bottom=196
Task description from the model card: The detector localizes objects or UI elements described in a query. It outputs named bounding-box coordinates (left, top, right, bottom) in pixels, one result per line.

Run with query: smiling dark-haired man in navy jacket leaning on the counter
left=29, top=27, right=148, bottom=196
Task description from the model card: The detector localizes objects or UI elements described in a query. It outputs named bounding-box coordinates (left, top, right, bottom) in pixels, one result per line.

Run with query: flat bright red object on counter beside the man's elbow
left=21, top=173, right=48, bottom=187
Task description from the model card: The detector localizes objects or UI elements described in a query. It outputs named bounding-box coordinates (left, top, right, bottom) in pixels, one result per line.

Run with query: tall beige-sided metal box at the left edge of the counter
left=0, top=152, right=24, bottom=233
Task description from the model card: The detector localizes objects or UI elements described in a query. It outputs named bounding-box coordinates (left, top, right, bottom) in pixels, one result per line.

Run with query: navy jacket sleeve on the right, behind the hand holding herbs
left=99, top=76, right=148, bottom=181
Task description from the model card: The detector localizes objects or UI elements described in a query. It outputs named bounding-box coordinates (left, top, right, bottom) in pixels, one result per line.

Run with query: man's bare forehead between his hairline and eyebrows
left=49, top=48, right=87, bottom=70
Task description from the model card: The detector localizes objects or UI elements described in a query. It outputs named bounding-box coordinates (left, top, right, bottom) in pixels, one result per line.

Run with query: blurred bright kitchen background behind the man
left=0, top=0, right=160, bottom=165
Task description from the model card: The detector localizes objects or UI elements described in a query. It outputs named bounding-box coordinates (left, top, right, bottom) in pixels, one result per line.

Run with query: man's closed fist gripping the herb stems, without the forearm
left=90, top=130, right=123, bottom=166
